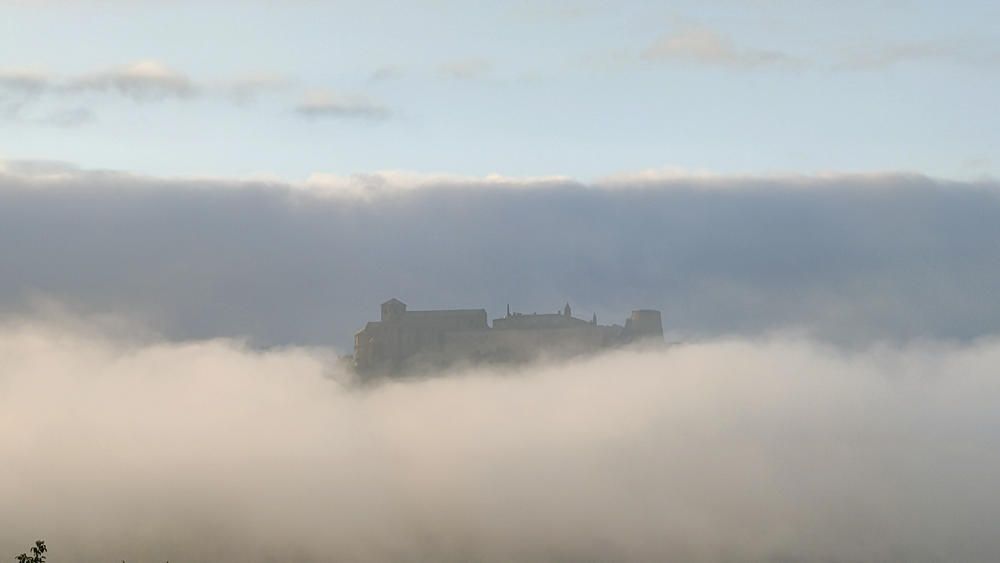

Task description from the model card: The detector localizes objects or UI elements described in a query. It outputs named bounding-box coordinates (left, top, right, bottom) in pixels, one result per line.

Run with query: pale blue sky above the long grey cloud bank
left=0, top=0, right=1000, bottom=180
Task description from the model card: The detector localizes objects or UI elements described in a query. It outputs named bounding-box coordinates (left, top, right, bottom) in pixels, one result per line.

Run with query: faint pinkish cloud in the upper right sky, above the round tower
left=641, top=27, right=804, bottom=69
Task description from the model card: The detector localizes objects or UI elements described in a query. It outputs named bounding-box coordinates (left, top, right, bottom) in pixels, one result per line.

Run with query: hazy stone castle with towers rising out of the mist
left=354, top=299, right=663, bottom=373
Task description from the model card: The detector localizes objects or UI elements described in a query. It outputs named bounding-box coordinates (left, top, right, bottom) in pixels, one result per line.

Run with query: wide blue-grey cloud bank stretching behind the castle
left=0, top=172, right=1000, bottom=351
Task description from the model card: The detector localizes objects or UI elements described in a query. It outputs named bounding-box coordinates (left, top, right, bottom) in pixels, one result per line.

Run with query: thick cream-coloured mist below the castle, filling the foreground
left=0, top=318, right=1000, bottom=562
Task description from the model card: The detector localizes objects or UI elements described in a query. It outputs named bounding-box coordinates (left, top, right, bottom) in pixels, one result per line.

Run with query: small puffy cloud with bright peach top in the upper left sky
left=67, top=61, right=198, bottom=101
